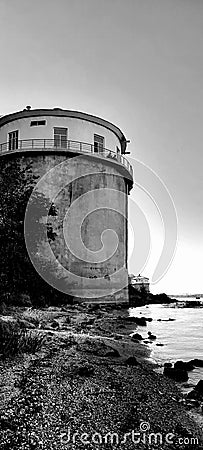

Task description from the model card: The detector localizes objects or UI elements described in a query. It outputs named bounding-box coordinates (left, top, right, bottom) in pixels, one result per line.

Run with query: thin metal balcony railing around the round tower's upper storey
left=0, top=139, right=133, bottom=176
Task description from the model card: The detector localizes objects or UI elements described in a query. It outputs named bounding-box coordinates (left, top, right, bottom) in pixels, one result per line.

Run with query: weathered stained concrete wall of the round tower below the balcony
left=2, top=152, right=128, bottom=302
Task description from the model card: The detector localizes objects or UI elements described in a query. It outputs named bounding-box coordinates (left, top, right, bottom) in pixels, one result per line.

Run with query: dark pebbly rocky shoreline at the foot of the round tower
left=0, top=304, right=203, bottom=450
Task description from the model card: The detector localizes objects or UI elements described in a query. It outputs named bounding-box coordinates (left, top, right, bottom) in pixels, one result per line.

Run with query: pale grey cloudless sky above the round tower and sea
left=0, top=0, right=203, bottom=294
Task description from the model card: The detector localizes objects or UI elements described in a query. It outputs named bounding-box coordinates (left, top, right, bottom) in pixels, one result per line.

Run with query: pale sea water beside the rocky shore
left=129, top=298, right=203, bottom=391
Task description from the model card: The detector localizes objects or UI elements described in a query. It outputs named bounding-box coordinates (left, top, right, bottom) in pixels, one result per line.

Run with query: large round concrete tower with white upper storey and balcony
left=0, top=106, right=133, bottom=302
